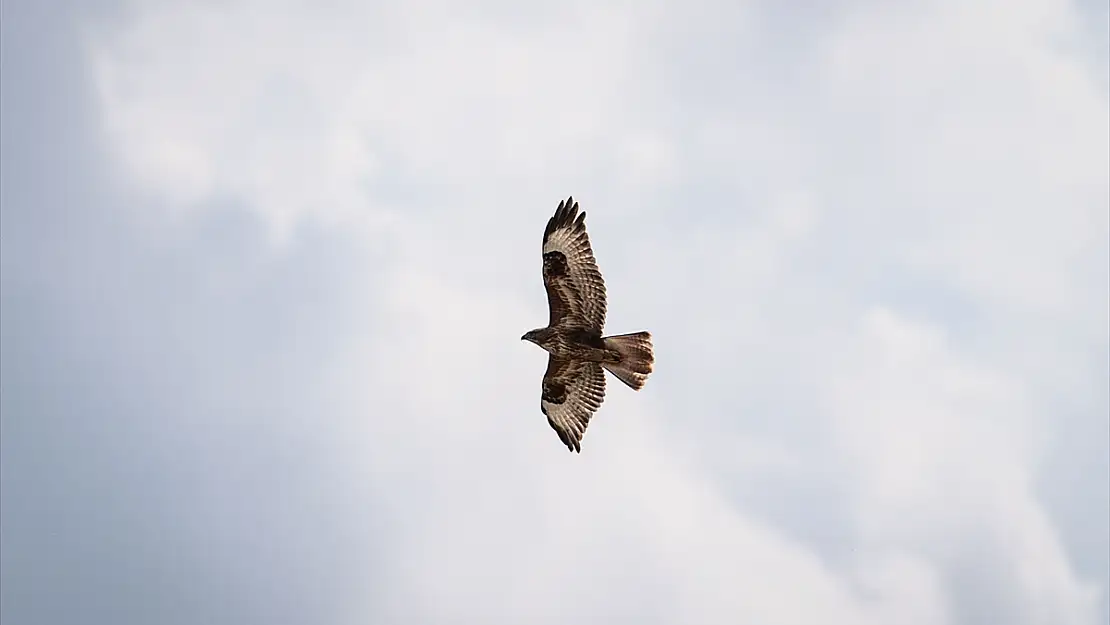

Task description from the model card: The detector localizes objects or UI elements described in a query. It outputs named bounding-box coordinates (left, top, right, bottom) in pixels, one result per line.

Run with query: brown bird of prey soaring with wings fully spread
left=521, top=196, right=655, bottom=453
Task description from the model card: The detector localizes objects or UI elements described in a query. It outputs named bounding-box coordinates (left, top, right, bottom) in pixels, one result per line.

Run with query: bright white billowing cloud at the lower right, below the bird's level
left=828, top=310, right=1099, bottom=623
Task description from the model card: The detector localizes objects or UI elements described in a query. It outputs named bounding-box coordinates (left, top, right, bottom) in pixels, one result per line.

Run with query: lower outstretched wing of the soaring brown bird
left=539, top=355, right=605, bottom=452
